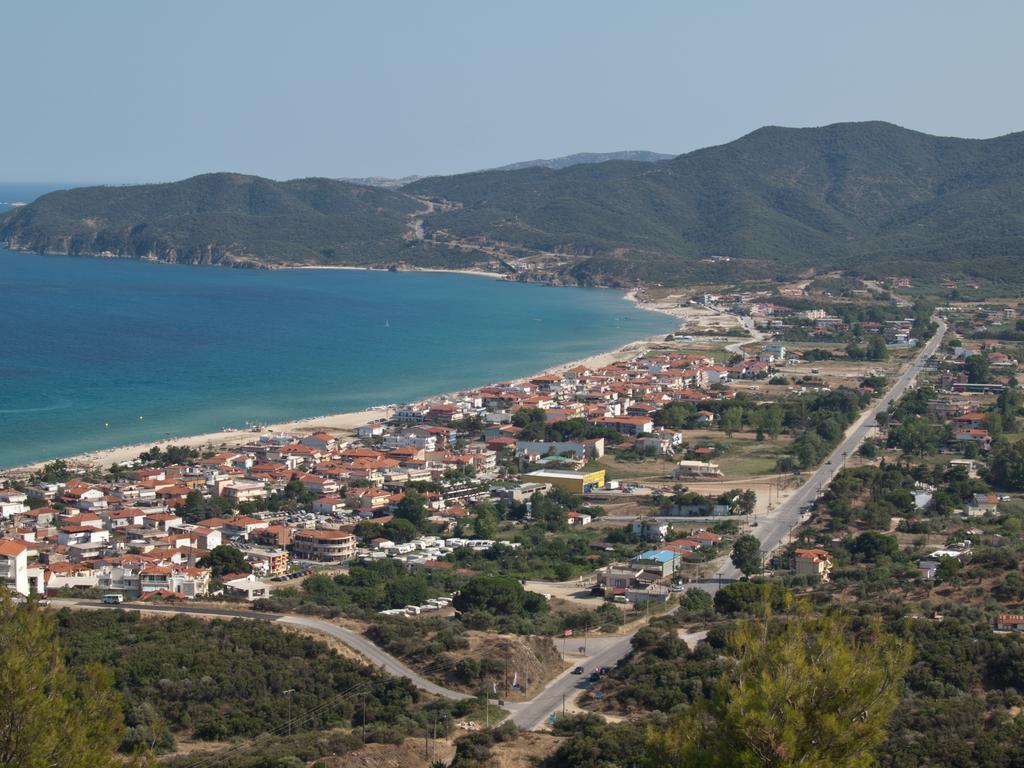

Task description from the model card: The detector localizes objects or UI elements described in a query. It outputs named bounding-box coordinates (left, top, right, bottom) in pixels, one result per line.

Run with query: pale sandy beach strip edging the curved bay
left=0, top=290, right=737, bottom=477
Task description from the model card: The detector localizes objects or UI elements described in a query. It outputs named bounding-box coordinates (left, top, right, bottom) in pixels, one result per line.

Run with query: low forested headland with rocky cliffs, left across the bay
left=0, top=173, right=421, bottom=264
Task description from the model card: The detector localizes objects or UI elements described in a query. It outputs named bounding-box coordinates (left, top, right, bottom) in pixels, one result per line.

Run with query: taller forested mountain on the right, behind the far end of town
left=406, top=123, right=1024, bottom=282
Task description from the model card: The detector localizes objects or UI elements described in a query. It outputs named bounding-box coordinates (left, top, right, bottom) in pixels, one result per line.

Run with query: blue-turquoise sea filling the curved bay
left=0, top=185, right=677, bottom=468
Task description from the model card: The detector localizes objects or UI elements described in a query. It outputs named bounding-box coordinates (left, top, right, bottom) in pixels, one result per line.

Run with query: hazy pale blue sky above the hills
left=0, top=0, right=1024, bottom=181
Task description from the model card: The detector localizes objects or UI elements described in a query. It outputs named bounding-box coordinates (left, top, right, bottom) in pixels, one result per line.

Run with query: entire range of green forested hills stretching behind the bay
left=6, top=122, right=1024, bottom=285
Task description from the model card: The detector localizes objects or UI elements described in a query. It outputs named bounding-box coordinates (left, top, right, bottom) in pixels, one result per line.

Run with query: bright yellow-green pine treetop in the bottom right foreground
left=646, top=606, right=910, bottom=768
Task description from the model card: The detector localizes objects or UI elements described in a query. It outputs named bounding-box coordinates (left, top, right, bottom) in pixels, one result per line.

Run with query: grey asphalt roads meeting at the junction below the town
left=46, top=321, right=946, bottom=730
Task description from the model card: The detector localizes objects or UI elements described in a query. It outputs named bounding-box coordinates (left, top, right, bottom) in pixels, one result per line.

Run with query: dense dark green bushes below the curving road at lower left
left=57, top=610, right=450, bottom=748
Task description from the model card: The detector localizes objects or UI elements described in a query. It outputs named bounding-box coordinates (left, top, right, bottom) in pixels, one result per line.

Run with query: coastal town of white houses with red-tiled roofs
left=0, top=282, right=1017, bottom=638
